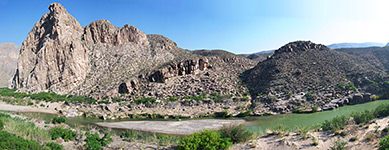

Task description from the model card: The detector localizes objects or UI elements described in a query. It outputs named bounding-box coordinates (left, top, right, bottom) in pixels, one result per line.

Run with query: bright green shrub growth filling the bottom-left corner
left=0, top=131, right=43, bottom=150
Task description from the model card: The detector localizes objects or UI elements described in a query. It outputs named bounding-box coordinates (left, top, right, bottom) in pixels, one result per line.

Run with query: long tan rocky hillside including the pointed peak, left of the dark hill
left=11, top=3, right=255, bottom=99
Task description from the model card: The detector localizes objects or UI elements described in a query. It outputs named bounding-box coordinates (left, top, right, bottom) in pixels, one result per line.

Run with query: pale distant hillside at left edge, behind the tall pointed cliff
left=0, top=43, right=20, bottom=87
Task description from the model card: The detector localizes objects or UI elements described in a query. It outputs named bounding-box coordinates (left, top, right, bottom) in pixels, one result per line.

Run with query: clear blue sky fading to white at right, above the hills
left=0, top=0, right=389, bottom=53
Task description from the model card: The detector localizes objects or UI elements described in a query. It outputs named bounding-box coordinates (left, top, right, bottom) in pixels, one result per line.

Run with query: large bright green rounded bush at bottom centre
left=177, top=130, right=232, bottom=150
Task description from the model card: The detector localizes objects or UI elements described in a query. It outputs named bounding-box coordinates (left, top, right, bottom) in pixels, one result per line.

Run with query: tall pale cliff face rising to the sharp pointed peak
left=11, top=3, right=89, bottom=93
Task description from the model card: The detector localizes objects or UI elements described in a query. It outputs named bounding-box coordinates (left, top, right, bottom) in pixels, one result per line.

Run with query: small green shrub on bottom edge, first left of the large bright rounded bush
left=85, top=132, right=113, bottom=150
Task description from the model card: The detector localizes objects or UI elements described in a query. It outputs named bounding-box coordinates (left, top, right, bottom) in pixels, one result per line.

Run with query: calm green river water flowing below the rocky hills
left=10, top=100, right=389, bottom=135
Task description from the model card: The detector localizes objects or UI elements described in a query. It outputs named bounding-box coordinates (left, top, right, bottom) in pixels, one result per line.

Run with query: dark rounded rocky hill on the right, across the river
left=242, top=41, right=387, bottom=111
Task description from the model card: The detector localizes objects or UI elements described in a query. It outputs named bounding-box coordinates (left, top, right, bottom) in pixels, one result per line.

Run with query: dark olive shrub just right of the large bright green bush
left=219, top=125, right=254, bottom=144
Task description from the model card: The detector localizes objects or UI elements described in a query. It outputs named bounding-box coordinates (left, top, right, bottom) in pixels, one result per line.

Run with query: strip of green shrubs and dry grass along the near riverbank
left=0, top=104, right=389, bottom=149
